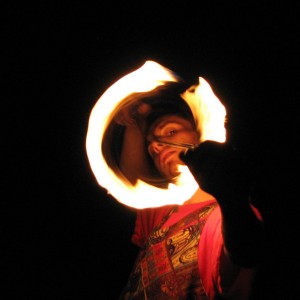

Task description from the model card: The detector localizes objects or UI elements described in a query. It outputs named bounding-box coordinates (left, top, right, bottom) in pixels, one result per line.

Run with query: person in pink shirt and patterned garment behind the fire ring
left=114, top=83, right=264, bottom=300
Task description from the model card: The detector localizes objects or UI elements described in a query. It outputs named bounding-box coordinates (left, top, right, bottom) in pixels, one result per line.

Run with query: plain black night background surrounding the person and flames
left=1, top=1, right=299, bottom=299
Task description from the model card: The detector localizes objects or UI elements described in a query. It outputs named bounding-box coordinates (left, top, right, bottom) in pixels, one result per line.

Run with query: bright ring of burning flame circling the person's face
left=86, top=61, right=226, bottom=209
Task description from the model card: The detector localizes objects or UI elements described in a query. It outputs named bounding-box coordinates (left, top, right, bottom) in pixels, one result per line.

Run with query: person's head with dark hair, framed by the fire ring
left=141, top=83, right=200, bottom=183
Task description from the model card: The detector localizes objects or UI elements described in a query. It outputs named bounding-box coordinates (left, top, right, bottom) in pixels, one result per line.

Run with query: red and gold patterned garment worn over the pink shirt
left=119, top=203, right=216, bottom=300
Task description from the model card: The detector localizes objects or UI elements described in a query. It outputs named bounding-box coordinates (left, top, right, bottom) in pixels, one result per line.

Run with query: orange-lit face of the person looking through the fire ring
left=147, top=115, right=198, bottom=178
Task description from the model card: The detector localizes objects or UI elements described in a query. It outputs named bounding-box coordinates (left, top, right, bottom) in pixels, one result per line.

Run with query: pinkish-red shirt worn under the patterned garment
left=132, top=199, right=261, bottom=300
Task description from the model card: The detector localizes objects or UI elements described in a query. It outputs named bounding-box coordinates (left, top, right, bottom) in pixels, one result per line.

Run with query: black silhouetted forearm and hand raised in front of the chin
left=181, top=141, right=264, bottom=268
